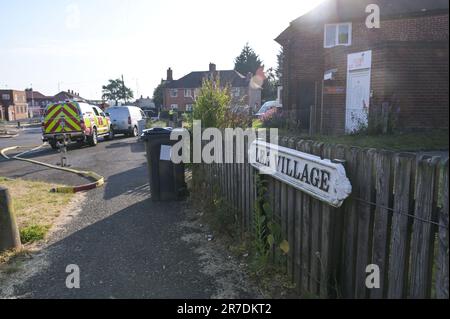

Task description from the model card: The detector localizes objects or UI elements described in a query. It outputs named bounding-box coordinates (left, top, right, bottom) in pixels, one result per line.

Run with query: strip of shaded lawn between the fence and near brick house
left=280, top=130, right=449, bottom=152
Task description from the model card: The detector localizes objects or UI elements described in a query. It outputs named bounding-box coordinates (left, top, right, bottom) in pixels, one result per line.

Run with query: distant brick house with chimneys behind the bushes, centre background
left=163, top=63, right=262, bottom=112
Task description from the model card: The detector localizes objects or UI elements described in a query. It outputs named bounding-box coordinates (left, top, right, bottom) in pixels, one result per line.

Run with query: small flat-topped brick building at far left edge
left=0, top=90, right=28, bottom=121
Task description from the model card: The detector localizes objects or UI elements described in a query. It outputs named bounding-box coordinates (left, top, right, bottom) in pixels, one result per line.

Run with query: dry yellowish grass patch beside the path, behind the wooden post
left=0, top=177, right=74, bottom=244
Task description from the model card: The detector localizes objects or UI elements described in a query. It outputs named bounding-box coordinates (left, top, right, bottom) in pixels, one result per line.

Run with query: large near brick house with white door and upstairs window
left=276, top=0, right=449, bottom=134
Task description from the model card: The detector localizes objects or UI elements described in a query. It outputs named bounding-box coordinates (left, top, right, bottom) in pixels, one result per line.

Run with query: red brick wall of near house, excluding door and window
left=283, top=14, right=448, bottom=134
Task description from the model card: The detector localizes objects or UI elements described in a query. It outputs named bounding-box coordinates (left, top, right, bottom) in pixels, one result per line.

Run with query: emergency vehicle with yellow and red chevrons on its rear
left=42, top=101, right=114, bottom=149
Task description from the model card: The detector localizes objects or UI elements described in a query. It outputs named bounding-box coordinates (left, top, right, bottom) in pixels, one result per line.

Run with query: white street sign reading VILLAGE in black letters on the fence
left=249, top=140, right=352, bottom=207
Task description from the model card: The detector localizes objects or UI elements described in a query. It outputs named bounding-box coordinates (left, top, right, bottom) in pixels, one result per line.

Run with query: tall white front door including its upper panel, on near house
left=345, top=51, right=372, bottom=133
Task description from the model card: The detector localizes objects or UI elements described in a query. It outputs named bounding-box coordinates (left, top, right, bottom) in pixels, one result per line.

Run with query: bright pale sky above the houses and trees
left=0, top=0, right=323, bottom=99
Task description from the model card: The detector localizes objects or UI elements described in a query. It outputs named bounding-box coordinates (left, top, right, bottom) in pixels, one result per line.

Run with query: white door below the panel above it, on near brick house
left=345, top=69, right=370, bottom=133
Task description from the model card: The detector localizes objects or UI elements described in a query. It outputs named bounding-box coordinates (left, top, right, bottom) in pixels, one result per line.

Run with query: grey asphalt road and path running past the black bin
left=0, top=129, right=258, bottom=299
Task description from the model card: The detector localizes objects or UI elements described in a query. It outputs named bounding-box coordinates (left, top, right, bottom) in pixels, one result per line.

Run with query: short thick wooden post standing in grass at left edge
left=0, top=187, right=22, bottom=252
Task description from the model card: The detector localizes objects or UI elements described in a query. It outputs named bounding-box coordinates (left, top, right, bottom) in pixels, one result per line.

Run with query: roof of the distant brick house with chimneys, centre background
left=166, top=70, right=249, bottom=89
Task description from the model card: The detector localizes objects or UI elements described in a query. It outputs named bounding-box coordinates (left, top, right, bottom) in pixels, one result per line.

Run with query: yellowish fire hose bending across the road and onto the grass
left=0, top=143, right=105, bottom=194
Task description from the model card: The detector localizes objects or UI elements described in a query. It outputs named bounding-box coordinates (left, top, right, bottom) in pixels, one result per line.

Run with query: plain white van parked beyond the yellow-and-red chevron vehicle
left=107, top=106, right=146, bottom=137
